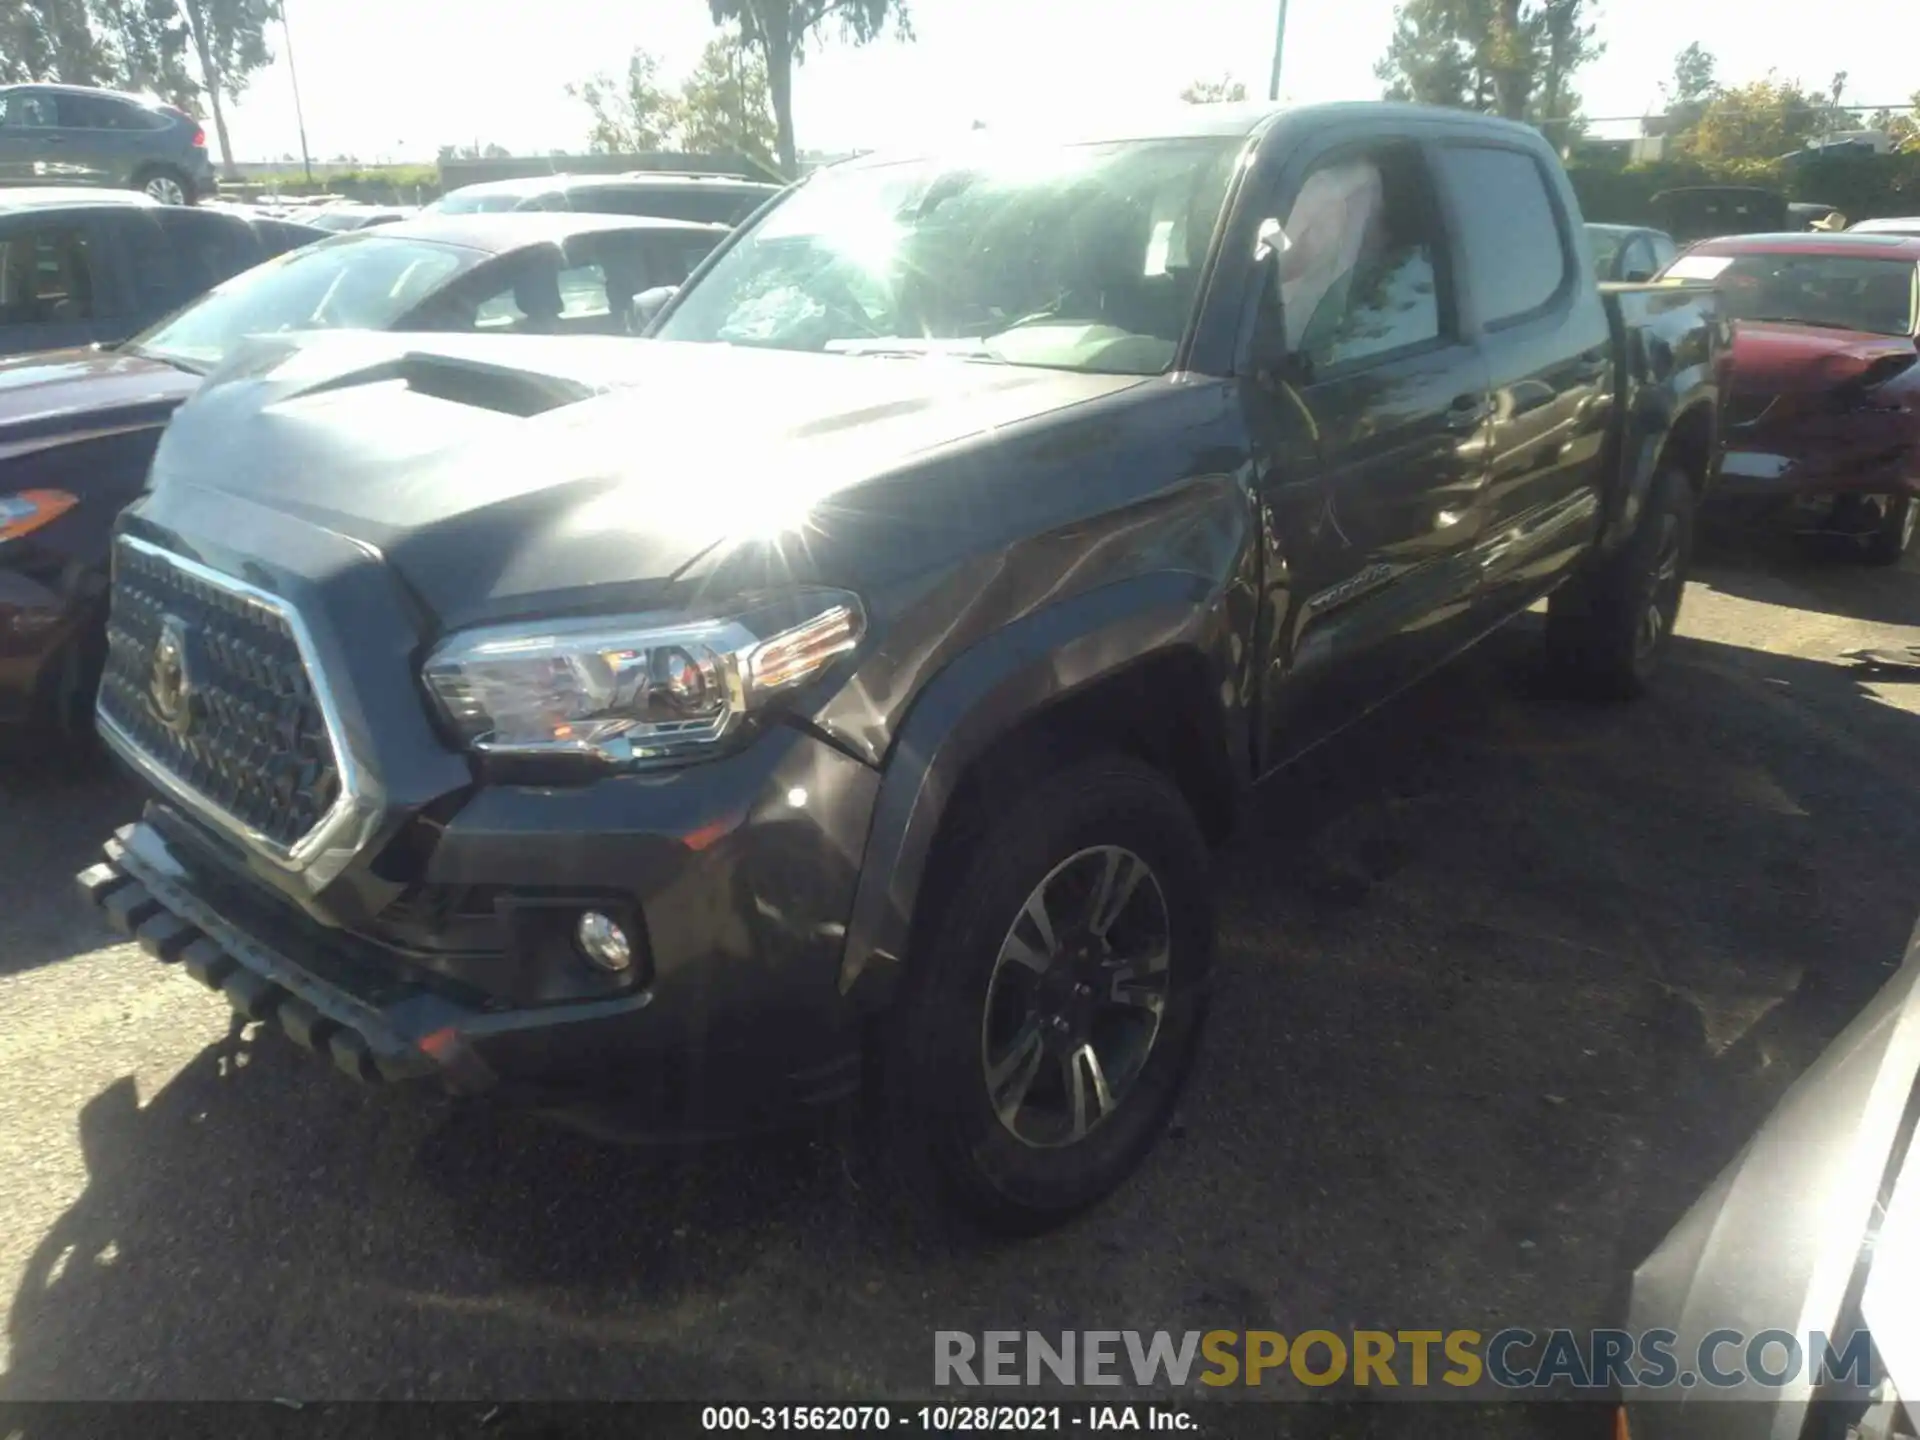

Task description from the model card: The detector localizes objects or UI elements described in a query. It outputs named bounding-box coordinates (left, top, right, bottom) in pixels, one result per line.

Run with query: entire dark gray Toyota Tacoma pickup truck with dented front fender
left=83, top=104, right=1720, bottom=1229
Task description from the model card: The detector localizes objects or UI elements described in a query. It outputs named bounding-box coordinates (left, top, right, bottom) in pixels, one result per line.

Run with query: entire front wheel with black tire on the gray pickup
left=883, top=755, right=1213, bottom=1235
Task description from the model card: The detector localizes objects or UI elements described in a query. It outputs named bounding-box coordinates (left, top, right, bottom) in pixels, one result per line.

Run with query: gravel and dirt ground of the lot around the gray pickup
left=0, top=545, right=1920, bottom=1400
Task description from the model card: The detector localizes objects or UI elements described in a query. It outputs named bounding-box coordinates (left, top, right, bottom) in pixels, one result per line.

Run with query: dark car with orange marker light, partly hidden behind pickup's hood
left=0, top=207, right=726, bottom=748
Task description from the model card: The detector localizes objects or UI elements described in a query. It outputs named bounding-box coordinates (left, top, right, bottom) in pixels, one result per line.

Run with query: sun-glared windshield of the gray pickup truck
left=657, top=138, right=1240, bottom=374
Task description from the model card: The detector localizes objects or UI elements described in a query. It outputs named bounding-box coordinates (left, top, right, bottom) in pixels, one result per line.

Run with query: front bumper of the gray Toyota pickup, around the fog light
left=79, top=733, right=877, bottom=1140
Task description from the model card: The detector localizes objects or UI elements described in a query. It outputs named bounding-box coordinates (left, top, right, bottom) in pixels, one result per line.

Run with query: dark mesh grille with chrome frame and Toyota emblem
left=100, top=540, right=342, bottom=854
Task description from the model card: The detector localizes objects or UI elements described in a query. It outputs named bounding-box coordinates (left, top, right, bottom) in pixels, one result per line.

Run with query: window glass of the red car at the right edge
left=1668, top=253, right=1916, bottom=334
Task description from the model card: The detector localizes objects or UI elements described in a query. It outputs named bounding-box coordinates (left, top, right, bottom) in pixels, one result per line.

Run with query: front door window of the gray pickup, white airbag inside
left=1263, top=148, right=1444, bottom=371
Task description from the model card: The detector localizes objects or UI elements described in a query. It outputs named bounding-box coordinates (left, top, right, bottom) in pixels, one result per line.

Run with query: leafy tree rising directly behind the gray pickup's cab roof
left=1373, top=0, right=1601, bottom=131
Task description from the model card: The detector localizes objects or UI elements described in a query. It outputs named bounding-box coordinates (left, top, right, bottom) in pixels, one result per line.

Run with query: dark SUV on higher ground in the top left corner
left=0, top=84, right=215, bottom=205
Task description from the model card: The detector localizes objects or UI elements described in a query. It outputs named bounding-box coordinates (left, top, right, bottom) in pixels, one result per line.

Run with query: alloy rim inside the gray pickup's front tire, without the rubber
left=981, top=845, right=1171, bottom=1148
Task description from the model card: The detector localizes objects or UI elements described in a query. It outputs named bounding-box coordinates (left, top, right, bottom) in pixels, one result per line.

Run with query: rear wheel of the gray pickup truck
left=1548, top=465, right=1695, bottom=701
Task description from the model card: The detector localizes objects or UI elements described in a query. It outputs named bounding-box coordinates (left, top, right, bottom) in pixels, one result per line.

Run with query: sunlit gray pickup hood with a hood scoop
left=152, top=334, right=1140, bottom=628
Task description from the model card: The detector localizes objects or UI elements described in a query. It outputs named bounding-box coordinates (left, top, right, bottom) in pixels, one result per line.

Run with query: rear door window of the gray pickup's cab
left=1440, top=146, right=1569, bottom=324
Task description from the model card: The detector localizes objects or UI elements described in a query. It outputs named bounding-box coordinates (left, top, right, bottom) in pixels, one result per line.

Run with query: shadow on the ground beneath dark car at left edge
left=0, top=749, right=140, bottom=975
